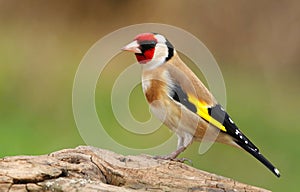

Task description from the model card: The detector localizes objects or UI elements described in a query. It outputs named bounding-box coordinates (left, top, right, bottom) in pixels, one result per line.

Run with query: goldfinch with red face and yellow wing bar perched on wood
left=122, top=32, right=280, bottom=177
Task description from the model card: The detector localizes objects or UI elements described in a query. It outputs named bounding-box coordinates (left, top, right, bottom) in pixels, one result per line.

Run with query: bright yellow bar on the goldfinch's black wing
left=188, top=94, right=227, bottom=132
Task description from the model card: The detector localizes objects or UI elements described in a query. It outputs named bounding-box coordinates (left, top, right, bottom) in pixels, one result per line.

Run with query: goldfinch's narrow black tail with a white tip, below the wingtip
left=236, top=141, right=280, bottom=177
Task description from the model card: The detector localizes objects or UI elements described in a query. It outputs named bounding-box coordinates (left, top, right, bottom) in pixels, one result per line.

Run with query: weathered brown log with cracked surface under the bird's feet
left=0, top=146, right=268, bottom=192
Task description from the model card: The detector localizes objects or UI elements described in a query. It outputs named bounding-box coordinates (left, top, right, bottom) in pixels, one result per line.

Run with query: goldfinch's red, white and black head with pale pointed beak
left=122, top=33, right=174, bottom=68
